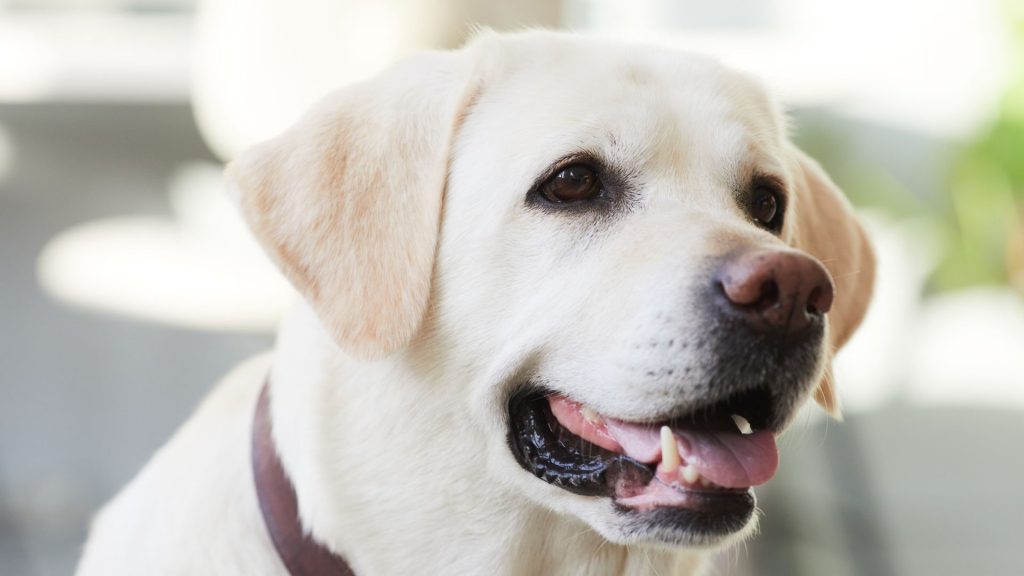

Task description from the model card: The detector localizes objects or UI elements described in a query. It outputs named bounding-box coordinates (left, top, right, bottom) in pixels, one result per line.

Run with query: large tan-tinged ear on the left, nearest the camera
left=227, top=46, right=477, bottom=358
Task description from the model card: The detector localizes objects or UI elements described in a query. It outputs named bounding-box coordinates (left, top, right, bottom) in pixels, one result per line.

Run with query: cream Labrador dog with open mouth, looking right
left=78, top=31, right=874, bottom=576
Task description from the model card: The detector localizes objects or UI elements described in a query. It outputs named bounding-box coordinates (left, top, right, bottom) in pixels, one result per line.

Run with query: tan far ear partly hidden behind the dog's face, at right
left=790, top=147, right=874, bottom=418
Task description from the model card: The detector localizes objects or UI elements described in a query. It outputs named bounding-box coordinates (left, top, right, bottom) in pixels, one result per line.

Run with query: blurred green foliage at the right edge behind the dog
left=797, top=0, right=1024, bottom=295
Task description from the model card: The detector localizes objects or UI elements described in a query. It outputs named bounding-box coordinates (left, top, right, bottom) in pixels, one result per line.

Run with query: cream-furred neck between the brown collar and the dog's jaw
left=271, top=306, right=702, bottom=574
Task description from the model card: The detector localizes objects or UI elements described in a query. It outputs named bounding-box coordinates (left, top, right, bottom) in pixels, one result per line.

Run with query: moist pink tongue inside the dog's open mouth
left=604, top=418, right=778, bottom=488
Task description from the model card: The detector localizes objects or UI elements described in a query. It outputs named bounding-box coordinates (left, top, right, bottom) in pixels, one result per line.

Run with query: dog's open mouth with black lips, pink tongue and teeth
left=509, top=388, right=778, bottom=535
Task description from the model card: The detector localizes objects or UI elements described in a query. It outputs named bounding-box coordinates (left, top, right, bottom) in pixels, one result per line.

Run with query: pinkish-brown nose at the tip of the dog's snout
left=717, top=250, right=835, bottom=334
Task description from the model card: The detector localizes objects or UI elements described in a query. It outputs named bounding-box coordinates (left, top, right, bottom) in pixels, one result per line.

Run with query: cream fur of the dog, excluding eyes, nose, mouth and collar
left=79, top=32, right=873, bottom=576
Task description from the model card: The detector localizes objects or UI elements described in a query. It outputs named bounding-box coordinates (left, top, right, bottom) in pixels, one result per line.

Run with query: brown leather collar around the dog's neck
left=252, top=383, right=355, bottom=576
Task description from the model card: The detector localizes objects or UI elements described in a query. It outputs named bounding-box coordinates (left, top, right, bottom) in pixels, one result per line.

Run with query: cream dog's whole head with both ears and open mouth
left=229, top=33, right=873, bottom=545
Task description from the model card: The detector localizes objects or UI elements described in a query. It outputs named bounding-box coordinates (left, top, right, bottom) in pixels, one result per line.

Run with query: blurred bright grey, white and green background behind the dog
left=0, top=0, right=1024, bottom=576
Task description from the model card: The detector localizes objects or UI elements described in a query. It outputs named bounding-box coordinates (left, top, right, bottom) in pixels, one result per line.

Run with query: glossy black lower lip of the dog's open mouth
left=508, top=388, right=755, bottom=543
